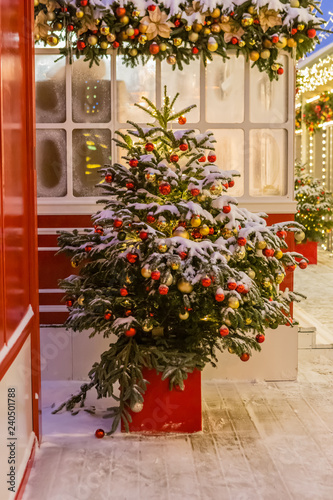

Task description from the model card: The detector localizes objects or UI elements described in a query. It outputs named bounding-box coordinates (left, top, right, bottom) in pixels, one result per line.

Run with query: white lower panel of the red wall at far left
left=0, top=336, right=35, bottom=500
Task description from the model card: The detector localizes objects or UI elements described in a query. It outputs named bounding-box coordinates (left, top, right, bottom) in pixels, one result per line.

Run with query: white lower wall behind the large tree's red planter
left=41, top=326, right=298, bottom=380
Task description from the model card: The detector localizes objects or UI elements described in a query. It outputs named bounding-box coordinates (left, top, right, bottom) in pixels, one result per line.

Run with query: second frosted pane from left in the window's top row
left=72, top=57, right=111, bottom=123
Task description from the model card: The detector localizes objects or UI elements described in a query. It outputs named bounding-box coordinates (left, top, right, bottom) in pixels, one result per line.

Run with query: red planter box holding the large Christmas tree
left=121, top=369, right=202, bottom=433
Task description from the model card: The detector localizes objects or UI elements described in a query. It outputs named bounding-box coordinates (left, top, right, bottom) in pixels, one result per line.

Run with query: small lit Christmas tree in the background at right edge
left=295, top=165, right=333, bottom=242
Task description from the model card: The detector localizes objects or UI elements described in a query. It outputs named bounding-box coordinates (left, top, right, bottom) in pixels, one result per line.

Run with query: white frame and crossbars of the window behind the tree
left=35, top=48, right=296, bottom=215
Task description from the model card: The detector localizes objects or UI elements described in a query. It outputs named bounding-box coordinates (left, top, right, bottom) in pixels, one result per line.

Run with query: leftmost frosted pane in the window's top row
left=35, top=54, right=66, bottom=123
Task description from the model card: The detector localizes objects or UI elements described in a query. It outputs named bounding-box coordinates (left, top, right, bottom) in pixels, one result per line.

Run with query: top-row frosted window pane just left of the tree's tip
left=117, top=56, right=156, bottom=123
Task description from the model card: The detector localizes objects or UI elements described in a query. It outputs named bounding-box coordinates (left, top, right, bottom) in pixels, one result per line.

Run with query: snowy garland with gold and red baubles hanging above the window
left=34, top=0, right=324, bottom=79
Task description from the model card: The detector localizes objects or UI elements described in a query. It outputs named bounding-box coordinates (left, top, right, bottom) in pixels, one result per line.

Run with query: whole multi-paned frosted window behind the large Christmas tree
left=36, top=48, right=294, bottom=214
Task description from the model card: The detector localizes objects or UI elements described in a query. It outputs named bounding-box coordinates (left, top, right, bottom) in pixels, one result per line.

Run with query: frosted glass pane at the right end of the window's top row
left=250, top=56, right=288, bottom=123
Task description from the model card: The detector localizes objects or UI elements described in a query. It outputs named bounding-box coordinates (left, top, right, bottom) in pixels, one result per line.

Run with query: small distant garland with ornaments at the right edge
left=296, top=92, right=333, bottom=134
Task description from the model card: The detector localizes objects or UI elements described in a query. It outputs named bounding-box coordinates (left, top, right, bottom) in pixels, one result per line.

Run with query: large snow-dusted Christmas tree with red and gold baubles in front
left=56, top=89, right=306, bottom=433
